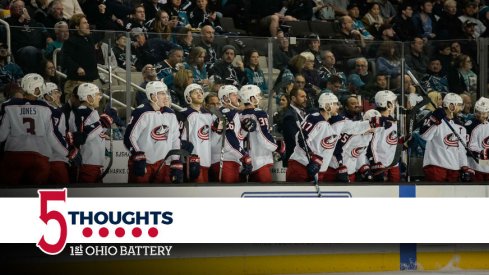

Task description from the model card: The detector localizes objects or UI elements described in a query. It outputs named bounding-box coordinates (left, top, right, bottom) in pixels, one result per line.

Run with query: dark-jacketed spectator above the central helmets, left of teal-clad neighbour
left=208, top=45, right=245, bottom=88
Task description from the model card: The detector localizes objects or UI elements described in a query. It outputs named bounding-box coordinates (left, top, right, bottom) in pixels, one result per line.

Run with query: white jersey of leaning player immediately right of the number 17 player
left=329, top=133, right=373, bottom=175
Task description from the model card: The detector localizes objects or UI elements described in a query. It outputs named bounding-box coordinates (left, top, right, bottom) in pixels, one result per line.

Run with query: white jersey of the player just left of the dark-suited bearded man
left=240, top=109, right=277, bottom=171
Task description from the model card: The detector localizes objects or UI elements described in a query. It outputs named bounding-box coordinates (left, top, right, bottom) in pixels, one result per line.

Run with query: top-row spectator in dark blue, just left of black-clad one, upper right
left=413, top=0, right=437, bottom=39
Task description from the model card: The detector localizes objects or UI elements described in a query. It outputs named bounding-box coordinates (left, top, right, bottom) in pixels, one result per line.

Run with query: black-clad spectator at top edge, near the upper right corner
left=438, top=0, right=463, bottom=40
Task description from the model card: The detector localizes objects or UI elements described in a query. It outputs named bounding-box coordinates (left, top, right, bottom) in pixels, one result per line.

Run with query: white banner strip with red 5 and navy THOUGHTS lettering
left=0, top=190, right=489, bottom=253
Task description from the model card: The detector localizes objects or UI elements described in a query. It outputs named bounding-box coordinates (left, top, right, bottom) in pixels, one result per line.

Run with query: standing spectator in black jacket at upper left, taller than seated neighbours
left=61, top=13, right=103, bottom=99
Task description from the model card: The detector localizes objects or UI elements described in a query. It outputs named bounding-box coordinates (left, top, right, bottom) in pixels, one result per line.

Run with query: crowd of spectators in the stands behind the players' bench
left=0, top=0, right=489, bottom=185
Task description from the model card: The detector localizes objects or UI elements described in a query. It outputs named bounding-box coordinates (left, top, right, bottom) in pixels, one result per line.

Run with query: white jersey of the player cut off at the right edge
left=465, top=119, right=489, bottom=173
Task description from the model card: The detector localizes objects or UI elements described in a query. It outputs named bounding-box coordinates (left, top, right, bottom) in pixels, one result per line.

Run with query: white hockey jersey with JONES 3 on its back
left=0, top=98, right=68, bottom=158
